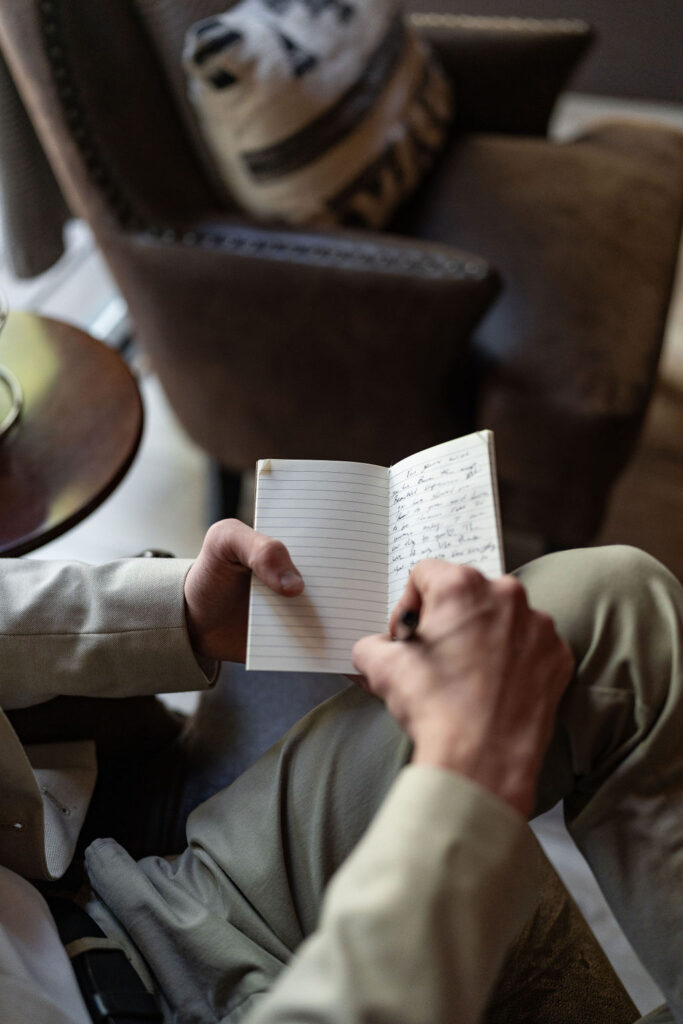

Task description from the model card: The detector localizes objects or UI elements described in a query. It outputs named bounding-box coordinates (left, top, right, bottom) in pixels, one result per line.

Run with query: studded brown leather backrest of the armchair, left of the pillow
left=3, top=0, right=224, bottom=230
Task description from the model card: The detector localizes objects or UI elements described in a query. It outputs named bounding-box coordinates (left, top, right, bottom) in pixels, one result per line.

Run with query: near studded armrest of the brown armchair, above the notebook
left=108, top=220, right=499, bottom=469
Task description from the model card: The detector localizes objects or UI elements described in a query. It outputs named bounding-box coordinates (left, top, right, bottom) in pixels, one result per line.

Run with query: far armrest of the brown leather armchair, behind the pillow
left=411, top=14, right=594, bottom=135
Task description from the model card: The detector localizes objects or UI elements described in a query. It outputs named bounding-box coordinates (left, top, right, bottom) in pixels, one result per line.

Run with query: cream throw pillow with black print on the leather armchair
left=183, top=0, right=452, bottom=227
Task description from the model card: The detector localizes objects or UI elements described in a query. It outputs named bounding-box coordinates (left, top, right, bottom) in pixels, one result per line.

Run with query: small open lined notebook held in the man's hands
left=247, top=430, right=504, bottom=673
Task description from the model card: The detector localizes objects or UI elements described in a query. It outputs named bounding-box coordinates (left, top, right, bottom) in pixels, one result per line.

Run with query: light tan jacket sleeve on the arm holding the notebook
left=0, top=558, right=216, bottom=710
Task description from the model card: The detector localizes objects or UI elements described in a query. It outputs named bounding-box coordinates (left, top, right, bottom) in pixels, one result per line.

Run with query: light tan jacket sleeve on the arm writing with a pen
left=246, top=765, right=539, bottom=1024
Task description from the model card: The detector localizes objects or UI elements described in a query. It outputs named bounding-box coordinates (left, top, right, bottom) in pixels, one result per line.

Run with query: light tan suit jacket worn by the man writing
left=0, top=559, right=538, bottom=1024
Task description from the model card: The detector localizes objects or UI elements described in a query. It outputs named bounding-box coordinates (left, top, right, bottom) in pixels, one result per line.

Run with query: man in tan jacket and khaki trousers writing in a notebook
left=0, top=522, right=683, bottom=1024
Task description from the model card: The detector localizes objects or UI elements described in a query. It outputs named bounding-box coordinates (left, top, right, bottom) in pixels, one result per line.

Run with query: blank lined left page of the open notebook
left=247, top=459, right=388, bottom=672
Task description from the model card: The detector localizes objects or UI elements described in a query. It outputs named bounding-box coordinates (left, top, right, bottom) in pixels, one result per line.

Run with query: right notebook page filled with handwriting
left=388, top=430, right=504, bottom=611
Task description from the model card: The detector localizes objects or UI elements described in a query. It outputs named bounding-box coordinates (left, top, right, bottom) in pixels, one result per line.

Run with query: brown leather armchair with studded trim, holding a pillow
left=0, top=0, right=683, bottom=561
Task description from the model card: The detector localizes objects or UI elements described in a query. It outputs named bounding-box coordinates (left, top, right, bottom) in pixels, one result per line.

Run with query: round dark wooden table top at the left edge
left=0, top=312, right=142, bottom=556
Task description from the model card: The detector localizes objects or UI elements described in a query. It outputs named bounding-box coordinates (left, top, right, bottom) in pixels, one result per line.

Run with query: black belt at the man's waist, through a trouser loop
left=45, top=894, right=163, bottom=1024
